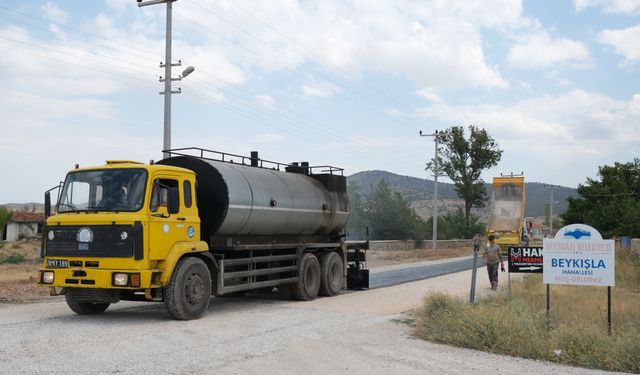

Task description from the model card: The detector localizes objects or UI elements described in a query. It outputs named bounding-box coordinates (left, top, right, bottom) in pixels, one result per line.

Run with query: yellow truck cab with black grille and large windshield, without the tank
left=38, top=161, right=211, bottom=314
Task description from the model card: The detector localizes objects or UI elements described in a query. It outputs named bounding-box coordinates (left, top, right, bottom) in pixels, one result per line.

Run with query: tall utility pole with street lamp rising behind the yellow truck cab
left=136, top=0, right=194, bottom=159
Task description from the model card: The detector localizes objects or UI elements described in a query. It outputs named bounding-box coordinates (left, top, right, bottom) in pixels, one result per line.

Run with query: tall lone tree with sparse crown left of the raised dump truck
left=427, top=125, right=502, bottom=237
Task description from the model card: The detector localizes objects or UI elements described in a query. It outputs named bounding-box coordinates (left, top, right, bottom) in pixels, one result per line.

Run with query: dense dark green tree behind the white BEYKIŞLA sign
left=561, top=158, right=640, bottom=237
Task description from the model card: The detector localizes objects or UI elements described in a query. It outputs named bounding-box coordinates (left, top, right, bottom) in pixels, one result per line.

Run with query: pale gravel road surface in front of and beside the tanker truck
left=0, top=269, right=620, bottom=374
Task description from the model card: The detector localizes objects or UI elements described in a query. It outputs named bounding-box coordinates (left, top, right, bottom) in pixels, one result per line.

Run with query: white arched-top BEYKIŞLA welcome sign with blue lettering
left=542, top=224, right=616, bottom=286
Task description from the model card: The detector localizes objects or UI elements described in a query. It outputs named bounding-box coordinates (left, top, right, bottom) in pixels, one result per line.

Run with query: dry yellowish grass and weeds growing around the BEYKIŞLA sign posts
left=414, top=250, right=640, bottom=373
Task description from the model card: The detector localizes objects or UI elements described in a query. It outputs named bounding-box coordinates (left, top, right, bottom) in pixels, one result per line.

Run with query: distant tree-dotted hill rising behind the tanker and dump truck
left=347, top=170, right=578, bottom=218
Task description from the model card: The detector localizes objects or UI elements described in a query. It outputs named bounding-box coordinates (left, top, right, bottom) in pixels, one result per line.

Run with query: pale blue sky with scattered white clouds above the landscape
left=0, top=0, right=640, bottom=203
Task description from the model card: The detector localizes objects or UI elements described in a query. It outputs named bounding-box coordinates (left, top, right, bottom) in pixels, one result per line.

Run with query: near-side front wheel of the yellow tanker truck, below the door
left=164, top=257, right=211, bottom=320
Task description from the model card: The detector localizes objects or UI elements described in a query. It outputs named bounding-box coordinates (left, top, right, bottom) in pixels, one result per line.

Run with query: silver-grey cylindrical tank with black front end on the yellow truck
left=159, top=156, right=349, bottom=242
